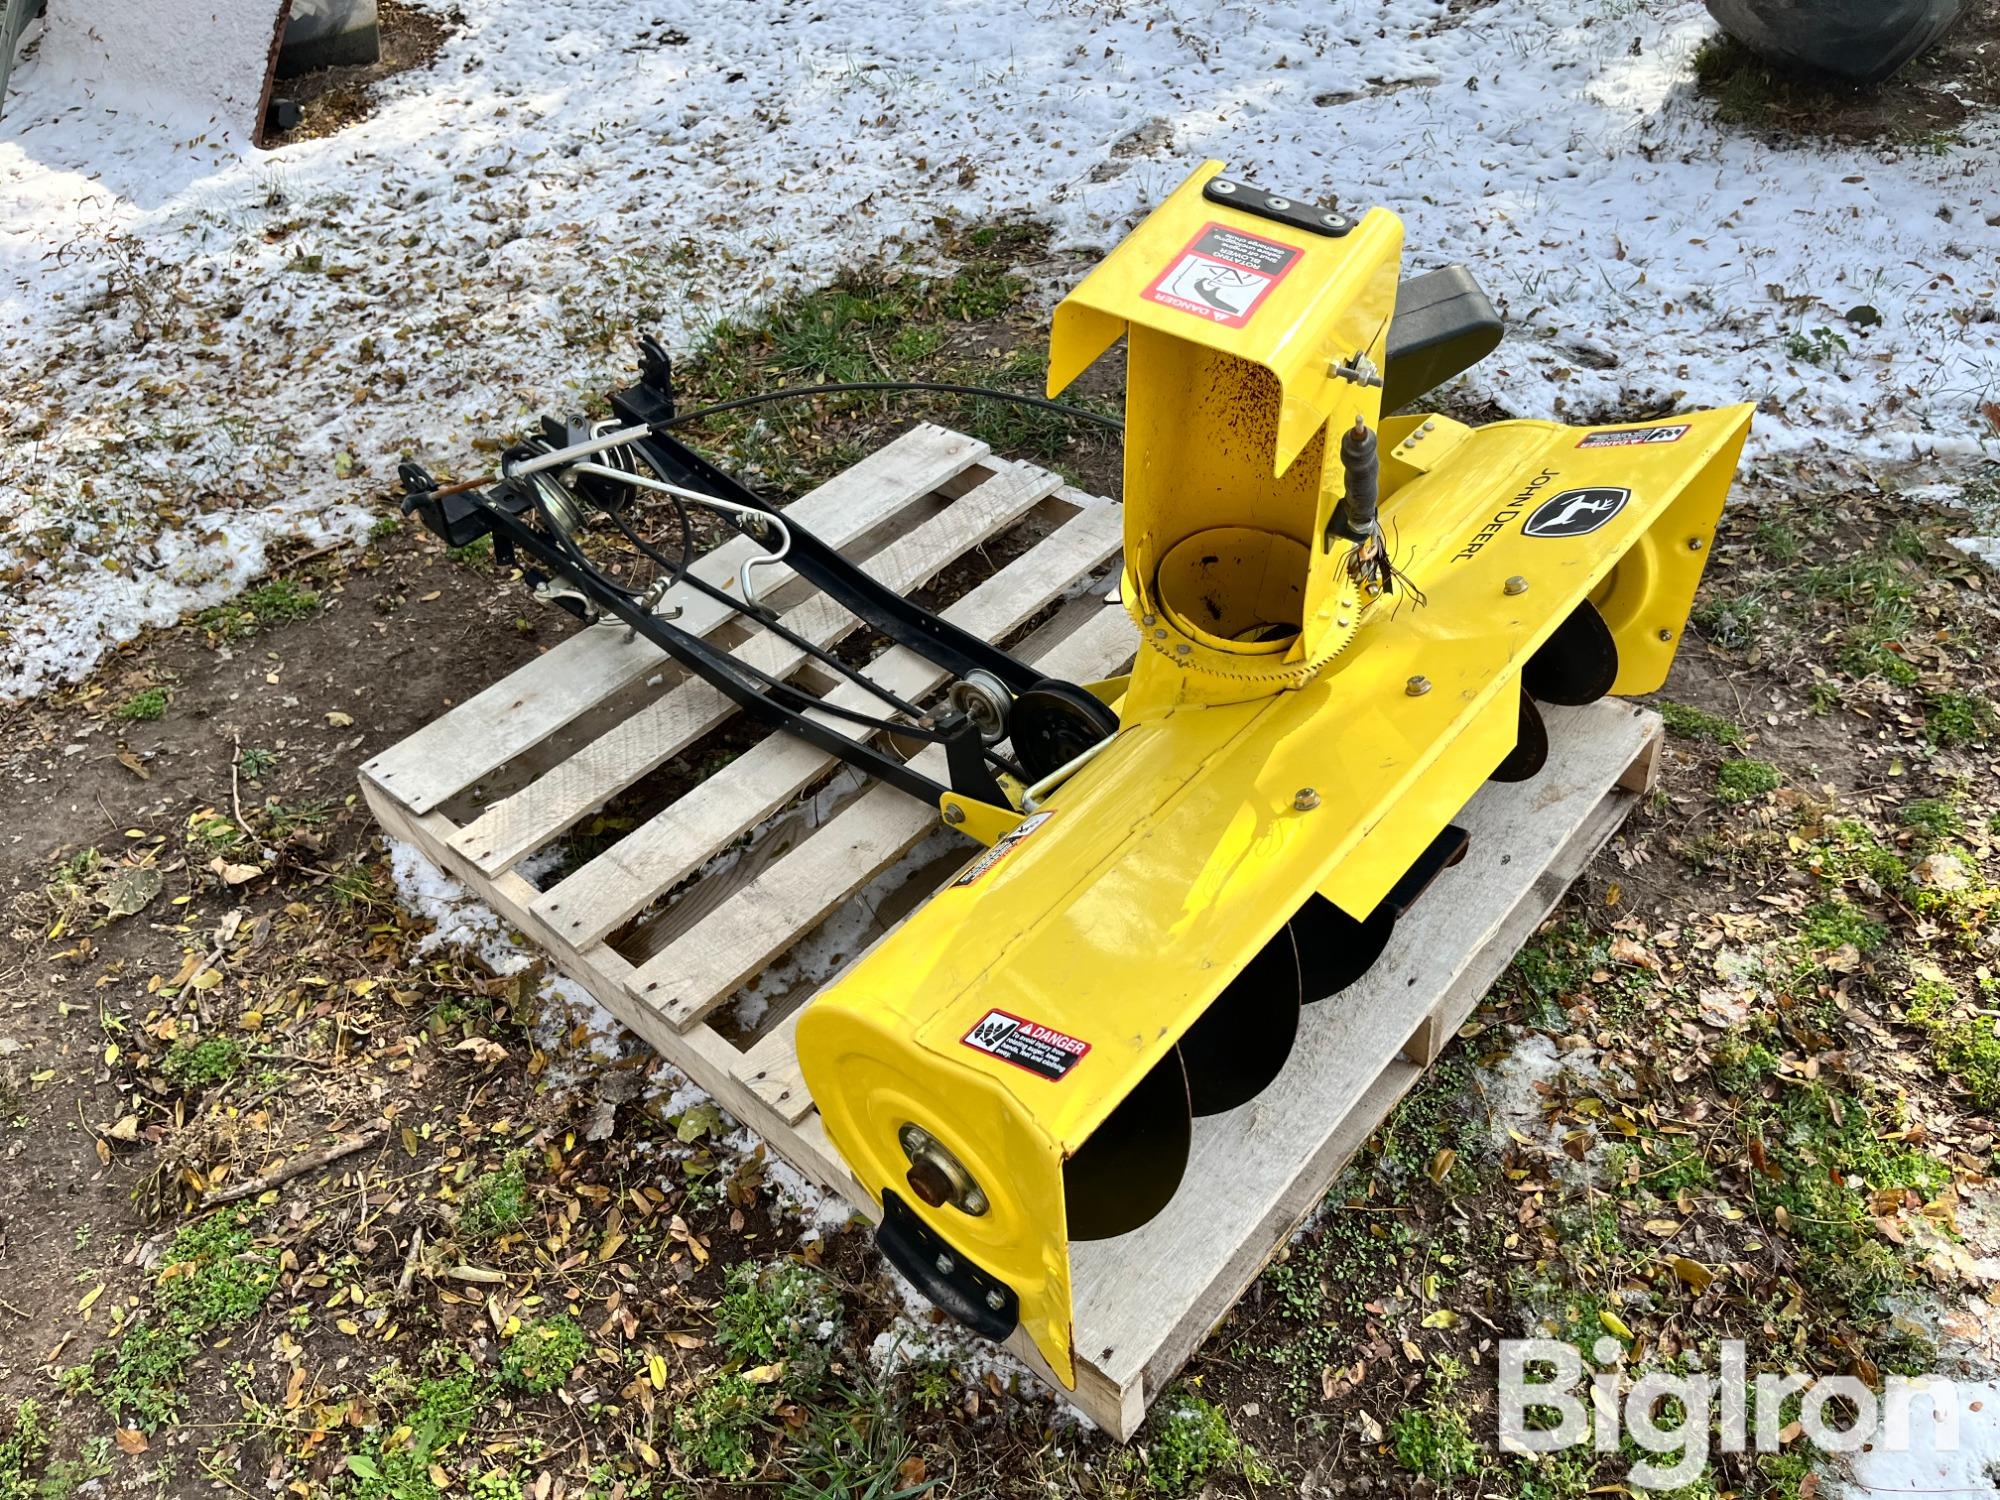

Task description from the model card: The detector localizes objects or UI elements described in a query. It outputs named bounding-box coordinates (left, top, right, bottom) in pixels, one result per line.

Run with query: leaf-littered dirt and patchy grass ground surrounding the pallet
left=0, top=29, right=2000, bottom=1500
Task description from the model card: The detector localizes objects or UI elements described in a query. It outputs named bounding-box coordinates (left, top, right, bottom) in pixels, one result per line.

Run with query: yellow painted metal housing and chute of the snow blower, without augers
left=798, top=164, right=1750, bottom=1378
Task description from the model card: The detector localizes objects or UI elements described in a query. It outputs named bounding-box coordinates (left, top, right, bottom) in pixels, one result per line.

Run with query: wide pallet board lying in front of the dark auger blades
left=1070, top=700, right=1658, bottom=1388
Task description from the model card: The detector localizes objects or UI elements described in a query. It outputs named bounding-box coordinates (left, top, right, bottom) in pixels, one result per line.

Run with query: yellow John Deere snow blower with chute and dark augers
left=798, top=162, right=1752, bottom=1382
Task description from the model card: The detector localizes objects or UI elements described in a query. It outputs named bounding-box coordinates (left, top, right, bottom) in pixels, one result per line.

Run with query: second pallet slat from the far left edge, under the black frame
left=452, top=464, right=1062, bottom=874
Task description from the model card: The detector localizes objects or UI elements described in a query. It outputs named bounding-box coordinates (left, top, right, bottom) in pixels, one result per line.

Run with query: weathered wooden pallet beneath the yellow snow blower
left=362, top=426, right=1658, bottom=1438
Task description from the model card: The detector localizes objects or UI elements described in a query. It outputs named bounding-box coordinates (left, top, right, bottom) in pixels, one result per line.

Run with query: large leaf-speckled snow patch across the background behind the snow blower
left=0, top=0, right=2000, bottom=696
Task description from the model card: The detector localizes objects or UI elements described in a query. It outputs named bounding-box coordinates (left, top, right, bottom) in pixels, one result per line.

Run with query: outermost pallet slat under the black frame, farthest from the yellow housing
left=362, top=422, right=988, bottom=812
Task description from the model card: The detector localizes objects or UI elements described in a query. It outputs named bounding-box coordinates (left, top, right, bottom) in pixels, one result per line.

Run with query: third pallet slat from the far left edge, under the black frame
left=534, top=506, right=1122, bottom=948
